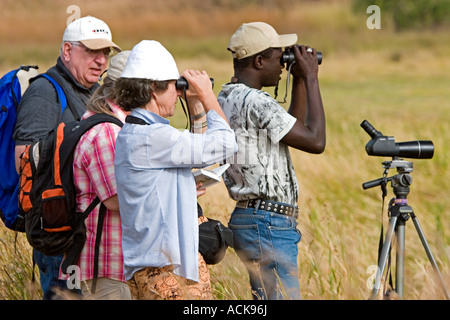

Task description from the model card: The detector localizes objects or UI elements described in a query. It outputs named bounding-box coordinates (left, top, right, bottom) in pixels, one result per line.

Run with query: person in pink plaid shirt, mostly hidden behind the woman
left=60, top=51, right=131, bottom=300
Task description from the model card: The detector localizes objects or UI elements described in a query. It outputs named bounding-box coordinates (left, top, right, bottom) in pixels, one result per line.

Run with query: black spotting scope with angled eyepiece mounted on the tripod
left=361, top=120, right=434, bottom=159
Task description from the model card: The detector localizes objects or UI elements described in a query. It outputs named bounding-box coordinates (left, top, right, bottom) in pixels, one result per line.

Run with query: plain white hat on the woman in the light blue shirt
left=120, top=40, right=180, bottom=81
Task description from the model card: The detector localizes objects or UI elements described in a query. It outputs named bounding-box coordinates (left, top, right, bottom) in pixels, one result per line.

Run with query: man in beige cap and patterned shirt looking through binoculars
left=218, top=22, right=325, bottom=299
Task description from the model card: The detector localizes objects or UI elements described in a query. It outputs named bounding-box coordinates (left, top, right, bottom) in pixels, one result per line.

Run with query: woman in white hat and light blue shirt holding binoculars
left=115, top=40, right=237, bottom=299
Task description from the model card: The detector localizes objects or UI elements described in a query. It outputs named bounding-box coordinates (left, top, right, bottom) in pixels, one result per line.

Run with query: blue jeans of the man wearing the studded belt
left=228, top=208, right=301, bottom=300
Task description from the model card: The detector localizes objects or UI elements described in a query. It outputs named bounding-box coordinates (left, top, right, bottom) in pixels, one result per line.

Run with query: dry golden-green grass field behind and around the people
left=0, top=0, right=450, bottom=300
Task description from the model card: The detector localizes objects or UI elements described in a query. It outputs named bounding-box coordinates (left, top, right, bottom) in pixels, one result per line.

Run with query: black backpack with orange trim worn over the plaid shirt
left=19, top=114, right=122, bottom=271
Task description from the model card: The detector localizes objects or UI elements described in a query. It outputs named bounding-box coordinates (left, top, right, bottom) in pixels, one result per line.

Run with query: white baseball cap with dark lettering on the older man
left=63, top=16, right=121, bottom=52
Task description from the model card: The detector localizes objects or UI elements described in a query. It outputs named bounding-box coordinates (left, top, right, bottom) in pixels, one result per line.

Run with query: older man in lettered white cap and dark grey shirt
left=13, top=16, right=120, bottom=299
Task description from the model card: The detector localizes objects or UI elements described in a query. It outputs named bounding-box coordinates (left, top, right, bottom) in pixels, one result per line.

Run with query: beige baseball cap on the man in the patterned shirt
left=227, top=22, right=298, bottom=59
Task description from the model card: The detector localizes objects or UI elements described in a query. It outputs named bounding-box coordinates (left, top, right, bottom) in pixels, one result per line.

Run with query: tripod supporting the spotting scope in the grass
left=363, top=158, right=450, bottom=300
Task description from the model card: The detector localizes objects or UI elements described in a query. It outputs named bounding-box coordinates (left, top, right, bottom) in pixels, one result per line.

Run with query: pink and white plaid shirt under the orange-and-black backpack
left=69, top=101, right=126, bottom=281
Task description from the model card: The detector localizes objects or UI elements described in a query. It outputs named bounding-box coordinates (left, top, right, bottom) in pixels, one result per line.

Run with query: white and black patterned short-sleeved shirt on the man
left=218, top=83, right=298, bottom=205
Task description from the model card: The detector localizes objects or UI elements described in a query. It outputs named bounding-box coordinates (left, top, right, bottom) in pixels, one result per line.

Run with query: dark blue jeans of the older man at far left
left=33, top=250, right=73, bottom=300
